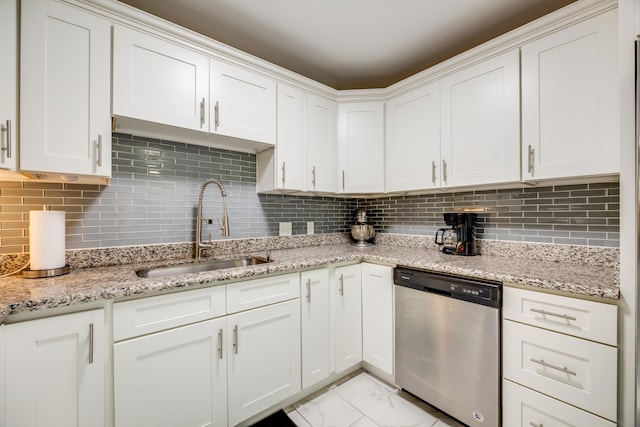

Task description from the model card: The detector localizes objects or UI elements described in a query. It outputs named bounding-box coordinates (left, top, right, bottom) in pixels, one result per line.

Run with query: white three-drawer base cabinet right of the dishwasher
left=502, top=287, right=618, bottom=427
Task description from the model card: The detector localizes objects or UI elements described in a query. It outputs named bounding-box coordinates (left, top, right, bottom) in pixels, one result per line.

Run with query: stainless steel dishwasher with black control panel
left=394, top=267, right=502, bottom=427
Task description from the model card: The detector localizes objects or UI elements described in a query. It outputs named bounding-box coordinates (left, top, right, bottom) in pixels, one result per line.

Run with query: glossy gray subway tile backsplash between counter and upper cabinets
left=0, top=134, right=620, bottom=254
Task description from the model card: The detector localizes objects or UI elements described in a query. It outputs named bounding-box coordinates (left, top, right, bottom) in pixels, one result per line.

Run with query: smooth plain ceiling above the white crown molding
left=121, top=0, right=574, bottom=89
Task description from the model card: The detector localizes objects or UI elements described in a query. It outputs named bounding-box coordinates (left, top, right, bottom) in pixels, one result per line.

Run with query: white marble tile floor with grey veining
left=285, top=371, right=464, bottom=427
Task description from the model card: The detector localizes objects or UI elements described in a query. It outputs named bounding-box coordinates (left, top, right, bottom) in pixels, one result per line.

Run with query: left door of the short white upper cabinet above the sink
left=113, top=25, right=209, bottom=132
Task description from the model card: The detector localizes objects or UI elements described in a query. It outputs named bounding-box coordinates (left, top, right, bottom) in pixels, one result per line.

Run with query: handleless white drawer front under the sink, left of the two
left=113, top=286, right=226, bottom=341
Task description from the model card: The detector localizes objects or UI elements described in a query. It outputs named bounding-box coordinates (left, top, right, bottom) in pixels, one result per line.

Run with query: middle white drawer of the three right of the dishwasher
left=502, top=320, right=618, bottom=420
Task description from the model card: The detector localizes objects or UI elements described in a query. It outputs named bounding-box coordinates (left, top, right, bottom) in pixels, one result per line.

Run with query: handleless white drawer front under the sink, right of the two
left=227, top=273, right=300, bottom=314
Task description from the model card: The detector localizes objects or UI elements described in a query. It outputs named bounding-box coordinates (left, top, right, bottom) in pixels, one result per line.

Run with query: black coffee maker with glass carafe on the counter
left=436, top=212, right=477, bottom=255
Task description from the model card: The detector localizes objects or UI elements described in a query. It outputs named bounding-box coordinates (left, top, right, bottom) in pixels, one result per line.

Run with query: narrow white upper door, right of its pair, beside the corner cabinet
left=307, top=93, right=338, bottom=193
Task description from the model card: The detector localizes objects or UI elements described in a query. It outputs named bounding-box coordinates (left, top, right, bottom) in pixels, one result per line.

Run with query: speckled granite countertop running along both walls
left=0, top=243, right=619, bottom=322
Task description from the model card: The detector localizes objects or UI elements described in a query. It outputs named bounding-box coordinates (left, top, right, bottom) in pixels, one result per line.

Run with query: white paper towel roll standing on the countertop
left=29, top=210, right=65, bottom=270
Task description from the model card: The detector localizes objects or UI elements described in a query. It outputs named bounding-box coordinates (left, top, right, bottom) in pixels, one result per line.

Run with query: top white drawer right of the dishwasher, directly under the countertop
left=502, top=286, right=618, bottom=346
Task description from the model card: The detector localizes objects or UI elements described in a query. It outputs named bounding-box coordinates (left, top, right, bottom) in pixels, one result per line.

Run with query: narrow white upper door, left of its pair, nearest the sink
left=275, top=83, right=307, bottom=191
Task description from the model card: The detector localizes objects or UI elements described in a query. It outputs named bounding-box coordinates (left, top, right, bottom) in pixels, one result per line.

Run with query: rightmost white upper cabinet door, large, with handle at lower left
left=522, top=10, right=620, bottom=179
